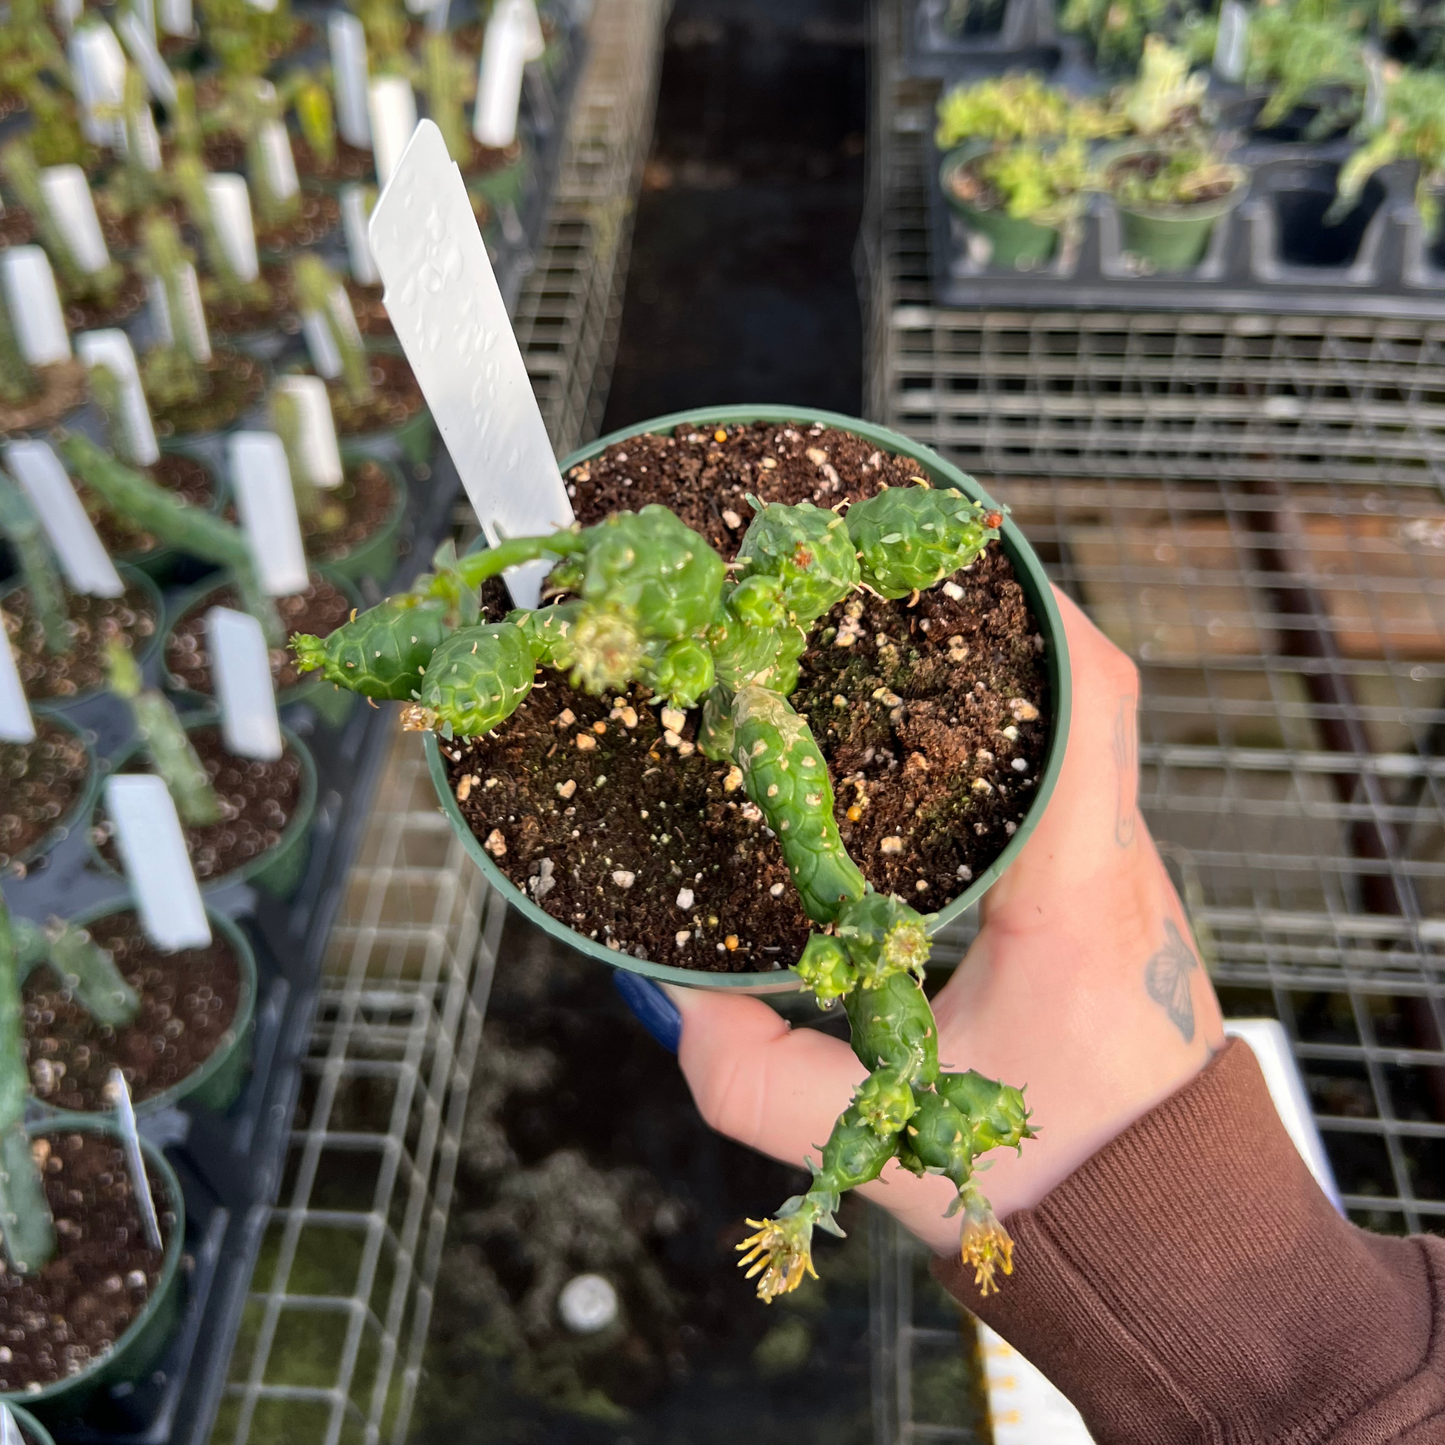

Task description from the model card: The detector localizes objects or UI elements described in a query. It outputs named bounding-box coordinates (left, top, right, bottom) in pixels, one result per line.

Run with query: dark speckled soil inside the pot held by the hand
left=444, top=425, right=1048, bottom=972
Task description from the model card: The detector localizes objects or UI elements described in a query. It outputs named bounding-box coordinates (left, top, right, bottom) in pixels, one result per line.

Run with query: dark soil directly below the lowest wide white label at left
left=22, top=913, right=241, bottom=1113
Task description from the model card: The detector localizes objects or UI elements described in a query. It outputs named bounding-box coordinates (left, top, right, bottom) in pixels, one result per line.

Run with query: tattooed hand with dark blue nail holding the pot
left=668, top=594, right=1224, bottom=1253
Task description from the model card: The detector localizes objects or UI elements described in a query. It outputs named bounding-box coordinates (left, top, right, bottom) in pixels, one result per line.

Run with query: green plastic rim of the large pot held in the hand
left=425, top=406, right=1074, bottom=994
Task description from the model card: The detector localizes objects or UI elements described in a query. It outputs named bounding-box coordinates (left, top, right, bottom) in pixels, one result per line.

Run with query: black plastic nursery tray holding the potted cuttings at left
left=4, top=451, right=460, bottom=1445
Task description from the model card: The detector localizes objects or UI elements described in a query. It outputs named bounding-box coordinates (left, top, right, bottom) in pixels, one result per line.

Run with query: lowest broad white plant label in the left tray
left=105, top=773, right=211, bottom=952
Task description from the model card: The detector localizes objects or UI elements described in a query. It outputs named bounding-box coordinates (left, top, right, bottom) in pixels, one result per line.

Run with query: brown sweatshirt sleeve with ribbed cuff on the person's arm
left=933, top=1040, right=1445, bottom=1445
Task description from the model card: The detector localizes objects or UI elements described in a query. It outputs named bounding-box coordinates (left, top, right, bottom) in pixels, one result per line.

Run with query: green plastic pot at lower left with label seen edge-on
left=0, top=1114, right=185, bottom=1425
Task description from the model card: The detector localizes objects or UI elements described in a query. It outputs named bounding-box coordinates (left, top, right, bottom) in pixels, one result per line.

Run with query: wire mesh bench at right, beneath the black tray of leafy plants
left=860, top=0, right=1445, bottom=1442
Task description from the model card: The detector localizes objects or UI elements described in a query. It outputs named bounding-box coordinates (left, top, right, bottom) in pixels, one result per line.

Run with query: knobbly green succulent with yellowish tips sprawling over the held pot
left=292, top=487, right=1032, bottom=1301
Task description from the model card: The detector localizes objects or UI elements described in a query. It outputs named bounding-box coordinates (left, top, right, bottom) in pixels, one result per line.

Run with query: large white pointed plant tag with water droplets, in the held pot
left=371, top=120, right=572, bottom=607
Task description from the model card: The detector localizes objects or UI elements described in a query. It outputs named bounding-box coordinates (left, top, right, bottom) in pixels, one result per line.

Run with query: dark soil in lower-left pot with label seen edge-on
left=0, top=1131, right=176, bottom=1393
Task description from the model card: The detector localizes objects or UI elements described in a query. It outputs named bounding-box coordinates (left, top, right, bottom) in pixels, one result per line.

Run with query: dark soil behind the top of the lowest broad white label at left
left=95, top=725, right=302, bottom=883
